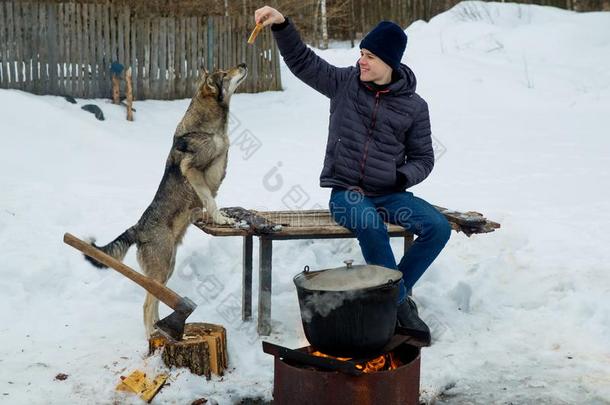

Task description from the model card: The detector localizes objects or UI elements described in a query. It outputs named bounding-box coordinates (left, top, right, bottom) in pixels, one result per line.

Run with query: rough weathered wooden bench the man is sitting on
left=195, top=206, right=500, bottom=336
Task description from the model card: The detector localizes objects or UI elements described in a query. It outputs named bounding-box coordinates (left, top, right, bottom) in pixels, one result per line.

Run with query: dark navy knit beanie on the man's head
left=360, top=21, right=407, bottom=70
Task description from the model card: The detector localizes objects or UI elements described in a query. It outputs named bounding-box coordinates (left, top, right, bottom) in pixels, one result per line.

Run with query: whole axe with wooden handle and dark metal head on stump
left=64, top=233, right=197, bottom=341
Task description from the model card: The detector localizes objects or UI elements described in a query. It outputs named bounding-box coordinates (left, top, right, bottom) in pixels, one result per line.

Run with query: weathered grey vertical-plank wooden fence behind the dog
left=0, top=0, right=281, bottom=100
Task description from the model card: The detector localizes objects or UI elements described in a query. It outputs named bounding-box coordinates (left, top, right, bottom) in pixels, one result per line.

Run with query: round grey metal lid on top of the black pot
left=294, top=260, right=402, bottom=291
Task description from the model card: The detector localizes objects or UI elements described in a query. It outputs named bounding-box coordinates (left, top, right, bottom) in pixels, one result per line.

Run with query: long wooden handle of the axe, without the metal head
left=64, top=233, right=182, bottom=310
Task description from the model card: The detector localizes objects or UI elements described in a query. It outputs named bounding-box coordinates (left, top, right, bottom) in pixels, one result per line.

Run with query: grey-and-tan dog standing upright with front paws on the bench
left=85, top=64, right=248, bottom=335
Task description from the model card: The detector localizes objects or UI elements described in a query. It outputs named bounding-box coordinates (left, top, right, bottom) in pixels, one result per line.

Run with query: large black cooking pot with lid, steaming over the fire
left=294, top=260, right=402, bottom=357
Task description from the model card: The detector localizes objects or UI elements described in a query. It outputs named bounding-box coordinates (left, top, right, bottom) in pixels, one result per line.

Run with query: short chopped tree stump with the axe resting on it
left=148, top=323, right=228, bottom=380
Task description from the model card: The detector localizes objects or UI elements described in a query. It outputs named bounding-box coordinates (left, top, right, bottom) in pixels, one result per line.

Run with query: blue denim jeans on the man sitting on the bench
left=329, top=188, right=451, bottom=304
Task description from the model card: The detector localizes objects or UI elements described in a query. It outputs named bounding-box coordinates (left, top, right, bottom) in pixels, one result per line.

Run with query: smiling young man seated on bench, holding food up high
left=254, top=6, right=451, bottom=345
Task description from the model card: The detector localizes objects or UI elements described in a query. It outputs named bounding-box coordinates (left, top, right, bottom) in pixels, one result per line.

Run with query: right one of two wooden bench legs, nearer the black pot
left=258, top=237, right=273, bottom=336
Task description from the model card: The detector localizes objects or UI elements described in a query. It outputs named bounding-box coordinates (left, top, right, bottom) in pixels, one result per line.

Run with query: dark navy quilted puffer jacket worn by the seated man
left=273, top=20, right=434, bottom=196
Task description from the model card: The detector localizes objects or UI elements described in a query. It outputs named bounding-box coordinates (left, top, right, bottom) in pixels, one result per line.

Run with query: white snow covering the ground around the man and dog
left=0, top=2, right=610, bottom=404
